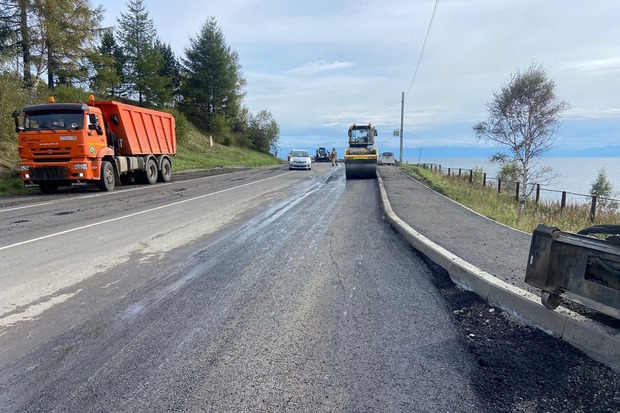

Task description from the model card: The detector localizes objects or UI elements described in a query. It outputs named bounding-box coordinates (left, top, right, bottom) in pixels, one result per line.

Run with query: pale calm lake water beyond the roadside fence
left=407, top=157, right=620, bottom=202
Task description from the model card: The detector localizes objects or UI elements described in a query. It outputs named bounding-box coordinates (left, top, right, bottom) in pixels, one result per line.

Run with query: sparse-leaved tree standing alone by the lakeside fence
left=474, top=64, right=570, bottom=204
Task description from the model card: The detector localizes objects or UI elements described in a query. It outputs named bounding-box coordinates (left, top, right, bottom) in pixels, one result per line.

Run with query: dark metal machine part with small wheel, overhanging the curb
left=525, top=224, right=620, bottom=319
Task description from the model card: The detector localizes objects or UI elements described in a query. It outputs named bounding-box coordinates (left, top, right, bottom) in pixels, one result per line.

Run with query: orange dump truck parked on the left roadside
left=13, top=99, right=177, bottom=193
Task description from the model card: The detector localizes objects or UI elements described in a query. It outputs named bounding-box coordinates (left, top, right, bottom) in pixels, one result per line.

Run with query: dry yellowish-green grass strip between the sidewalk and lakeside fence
left=402, top=165, right=620, bottom=233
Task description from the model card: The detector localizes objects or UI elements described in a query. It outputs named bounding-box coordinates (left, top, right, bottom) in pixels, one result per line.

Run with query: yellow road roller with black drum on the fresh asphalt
left=344, top=123, right=379, bottom=179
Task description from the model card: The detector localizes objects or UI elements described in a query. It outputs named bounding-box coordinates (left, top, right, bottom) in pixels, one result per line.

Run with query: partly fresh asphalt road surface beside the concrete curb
left=0, top=164, right=620, bottom=412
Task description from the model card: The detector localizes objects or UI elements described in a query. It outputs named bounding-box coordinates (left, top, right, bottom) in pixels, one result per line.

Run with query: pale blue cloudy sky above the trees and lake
left=99, top=0, right=620, bottom=156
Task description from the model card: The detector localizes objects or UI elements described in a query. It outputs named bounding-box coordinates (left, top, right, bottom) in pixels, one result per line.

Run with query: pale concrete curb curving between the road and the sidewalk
left=377, top=172, right=620, bottom=373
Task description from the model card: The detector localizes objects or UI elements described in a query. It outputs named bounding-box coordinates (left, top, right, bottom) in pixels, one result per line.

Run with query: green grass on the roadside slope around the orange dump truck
left=0, top=124, right=281, bottom=196
